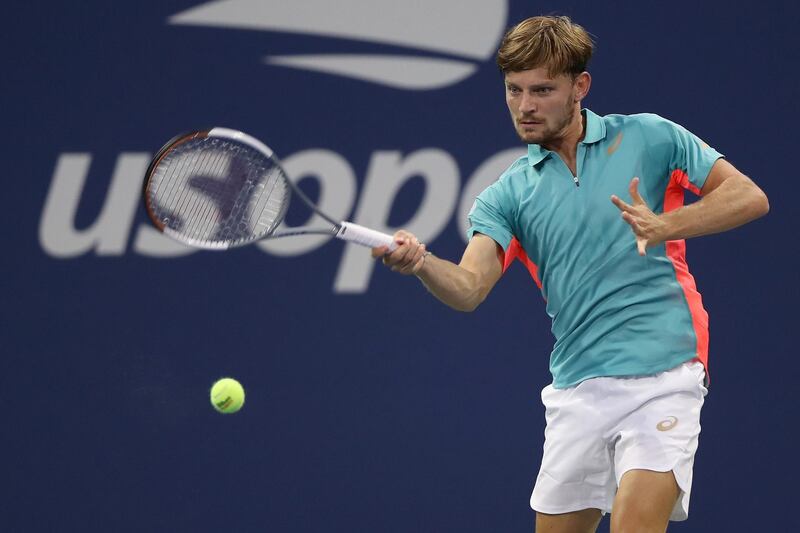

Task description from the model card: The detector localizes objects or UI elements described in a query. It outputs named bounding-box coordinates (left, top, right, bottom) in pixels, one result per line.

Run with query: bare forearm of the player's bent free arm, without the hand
left=660, top=175, right=769, bottom=241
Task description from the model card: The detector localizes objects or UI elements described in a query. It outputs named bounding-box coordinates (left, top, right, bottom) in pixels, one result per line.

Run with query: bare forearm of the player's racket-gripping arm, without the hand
left=417, top=255, right=490, bottom=311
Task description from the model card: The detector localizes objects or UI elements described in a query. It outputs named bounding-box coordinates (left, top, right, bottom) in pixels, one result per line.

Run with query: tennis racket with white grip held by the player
left=144, top=128, right=396, bottom=250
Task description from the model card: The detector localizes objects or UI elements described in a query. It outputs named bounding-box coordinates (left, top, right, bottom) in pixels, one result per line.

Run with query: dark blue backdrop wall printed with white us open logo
left=0, top=0, right=800, bottom=533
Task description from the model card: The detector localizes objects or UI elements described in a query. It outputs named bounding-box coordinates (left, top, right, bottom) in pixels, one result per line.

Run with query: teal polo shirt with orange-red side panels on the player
left=468, top=109, right=723, bottom=388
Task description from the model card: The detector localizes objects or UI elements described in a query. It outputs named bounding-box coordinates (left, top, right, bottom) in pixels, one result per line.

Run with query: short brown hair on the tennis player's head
left=497, top=16, right=594, bottom=77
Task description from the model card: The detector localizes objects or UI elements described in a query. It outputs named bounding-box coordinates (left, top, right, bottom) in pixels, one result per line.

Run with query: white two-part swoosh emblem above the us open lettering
left=168, top=0, right=508, bottom=90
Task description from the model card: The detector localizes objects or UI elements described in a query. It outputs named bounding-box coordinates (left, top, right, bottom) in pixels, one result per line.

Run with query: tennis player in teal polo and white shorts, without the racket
left=372, top=17, right=769, bottom=533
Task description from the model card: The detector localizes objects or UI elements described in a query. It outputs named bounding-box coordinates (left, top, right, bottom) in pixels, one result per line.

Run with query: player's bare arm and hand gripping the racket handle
left=372, top=231, right=503, bottom=311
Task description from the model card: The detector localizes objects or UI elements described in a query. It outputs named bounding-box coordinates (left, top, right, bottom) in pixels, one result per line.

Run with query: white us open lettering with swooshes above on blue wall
left=39, top=0, right=525, bottom=293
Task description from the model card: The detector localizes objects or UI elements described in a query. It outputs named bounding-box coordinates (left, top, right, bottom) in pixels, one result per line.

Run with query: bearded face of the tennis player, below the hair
left=505, top=67, right=580, bottom=145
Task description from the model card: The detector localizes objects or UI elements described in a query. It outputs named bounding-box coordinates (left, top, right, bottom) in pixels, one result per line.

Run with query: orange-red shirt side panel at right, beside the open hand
left=664, top=169, right=708, bottom=375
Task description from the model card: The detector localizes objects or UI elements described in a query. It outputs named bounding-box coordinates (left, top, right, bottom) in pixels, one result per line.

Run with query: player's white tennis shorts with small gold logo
left=531, top=361, right=708, bottom=520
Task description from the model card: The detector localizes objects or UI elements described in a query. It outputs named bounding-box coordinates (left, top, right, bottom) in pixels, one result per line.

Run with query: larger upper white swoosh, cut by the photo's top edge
left=168, top=0, right=508, bottom=60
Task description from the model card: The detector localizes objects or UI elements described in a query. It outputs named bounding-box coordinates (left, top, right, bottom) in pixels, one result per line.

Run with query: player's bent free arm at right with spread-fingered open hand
left=611, top=159, right=769, bottom=255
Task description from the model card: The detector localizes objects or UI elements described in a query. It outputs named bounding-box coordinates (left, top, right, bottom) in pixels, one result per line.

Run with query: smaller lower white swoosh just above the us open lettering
left=264, top=54, right=477, bottom=90
